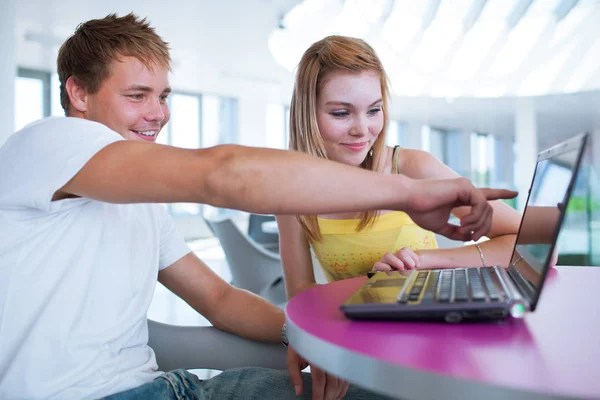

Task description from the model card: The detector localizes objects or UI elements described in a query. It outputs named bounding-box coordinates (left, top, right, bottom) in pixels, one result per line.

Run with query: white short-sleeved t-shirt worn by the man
left=0, top=117, right=190, bottom=399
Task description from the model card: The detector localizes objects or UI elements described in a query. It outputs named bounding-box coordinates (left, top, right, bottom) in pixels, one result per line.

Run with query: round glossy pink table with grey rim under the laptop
left=286, top=267, right=600, bottom=399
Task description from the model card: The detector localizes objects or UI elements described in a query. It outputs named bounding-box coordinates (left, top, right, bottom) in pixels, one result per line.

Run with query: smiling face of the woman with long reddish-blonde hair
left=317, top=71, right=383, bottom=166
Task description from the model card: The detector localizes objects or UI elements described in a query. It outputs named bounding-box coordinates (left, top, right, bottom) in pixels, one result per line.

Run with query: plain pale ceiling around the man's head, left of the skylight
left=16, top=0, right=298, bottom=94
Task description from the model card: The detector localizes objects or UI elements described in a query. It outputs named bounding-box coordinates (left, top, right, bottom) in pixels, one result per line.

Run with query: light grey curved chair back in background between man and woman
left=206, top=218, right=283, bottom=295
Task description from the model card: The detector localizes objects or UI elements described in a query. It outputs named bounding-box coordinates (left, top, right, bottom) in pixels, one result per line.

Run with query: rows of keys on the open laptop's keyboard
left=398, top=267, right=506, bottom=304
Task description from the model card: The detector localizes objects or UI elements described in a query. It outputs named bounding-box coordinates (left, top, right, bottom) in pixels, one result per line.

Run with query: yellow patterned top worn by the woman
left=311, top=211, right=437, bottom=282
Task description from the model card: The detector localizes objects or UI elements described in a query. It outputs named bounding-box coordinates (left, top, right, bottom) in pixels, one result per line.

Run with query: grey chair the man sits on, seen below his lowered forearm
left=148, top=320, right=287, bottom=371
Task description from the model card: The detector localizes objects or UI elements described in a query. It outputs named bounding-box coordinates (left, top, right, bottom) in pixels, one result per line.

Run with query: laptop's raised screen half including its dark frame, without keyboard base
left=509, top=135, right=586, bottom=311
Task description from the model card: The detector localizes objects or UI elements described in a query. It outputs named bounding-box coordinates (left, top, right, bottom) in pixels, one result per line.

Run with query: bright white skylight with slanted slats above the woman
left=269, top=0, right=600, bottom=98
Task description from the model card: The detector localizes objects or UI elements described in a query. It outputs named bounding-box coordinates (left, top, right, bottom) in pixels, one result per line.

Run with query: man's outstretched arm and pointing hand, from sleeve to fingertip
left=55, top=141, right=516, bottom=240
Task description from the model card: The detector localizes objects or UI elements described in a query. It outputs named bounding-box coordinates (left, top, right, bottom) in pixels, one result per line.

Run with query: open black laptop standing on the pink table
left=341, top=134, right=588, bottom=322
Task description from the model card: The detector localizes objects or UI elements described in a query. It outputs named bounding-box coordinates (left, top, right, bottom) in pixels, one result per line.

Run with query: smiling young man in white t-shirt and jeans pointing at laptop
left=0, top=14, right=514, bottom=399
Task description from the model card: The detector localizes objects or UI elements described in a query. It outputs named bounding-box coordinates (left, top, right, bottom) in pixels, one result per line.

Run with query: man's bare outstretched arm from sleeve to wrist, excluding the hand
left=60, top=141, right=410, bottom=214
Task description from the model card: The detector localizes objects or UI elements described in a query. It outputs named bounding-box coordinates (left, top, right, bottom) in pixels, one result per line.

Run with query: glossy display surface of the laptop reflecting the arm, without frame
left=511, top=147, right=579, bottom=290
